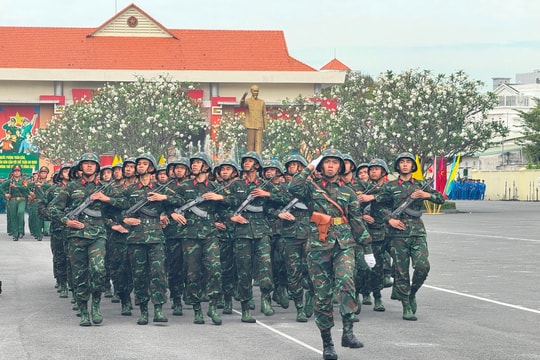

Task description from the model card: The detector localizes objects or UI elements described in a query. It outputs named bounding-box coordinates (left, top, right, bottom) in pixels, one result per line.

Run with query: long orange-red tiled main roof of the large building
left=0, top=27, right=317, bottom=71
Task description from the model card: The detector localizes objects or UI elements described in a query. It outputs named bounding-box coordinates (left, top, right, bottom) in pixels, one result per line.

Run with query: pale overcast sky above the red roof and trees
left=0, top=0, right=540, bottom=89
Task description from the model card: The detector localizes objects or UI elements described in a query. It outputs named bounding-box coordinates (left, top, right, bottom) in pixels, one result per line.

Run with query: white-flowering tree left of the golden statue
left=34, top=76, right=207, bottom=162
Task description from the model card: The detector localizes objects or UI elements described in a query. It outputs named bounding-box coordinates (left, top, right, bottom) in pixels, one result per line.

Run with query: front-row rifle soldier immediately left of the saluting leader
left=278, top=155, right=314, bottom=322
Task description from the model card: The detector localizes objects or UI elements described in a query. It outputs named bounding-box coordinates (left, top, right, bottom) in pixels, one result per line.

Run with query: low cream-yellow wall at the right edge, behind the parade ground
left=471, top=170, right=540, bottom=201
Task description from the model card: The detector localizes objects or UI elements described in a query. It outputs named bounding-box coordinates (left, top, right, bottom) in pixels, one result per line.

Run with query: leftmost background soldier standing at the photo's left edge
left=0, top=165, right=30, bottom=241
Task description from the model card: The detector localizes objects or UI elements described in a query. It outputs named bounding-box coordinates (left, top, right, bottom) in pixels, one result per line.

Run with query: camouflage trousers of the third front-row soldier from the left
left=182, top=236, right=221, bottom=304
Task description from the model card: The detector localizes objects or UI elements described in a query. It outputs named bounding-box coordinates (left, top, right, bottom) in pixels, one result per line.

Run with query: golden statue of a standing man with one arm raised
left=240, top=85, right=268, bottom=154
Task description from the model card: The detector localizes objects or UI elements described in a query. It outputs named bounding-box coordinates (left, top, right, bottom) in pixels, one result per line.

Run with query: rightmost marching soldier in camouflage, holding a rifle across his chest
left=375, top=153, right=444, bottom=321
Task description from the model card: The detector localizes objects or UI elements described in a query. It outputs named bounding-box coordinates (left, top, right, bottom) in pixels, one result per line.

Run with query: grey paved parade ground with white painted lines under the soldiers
left=0, top=201, right=540, bottom=360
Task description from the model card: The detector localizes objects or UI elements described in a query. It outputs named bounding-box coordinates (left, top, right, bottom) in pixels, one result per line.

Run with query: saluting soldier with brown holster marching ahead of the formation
left=289, top=149, right=375, bottom=359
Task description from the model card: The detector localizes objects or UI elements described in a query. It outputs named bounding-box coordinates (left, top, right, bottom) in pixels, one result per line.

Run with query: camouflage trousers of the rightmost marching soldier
left=390, top=235, right=430, bottom=299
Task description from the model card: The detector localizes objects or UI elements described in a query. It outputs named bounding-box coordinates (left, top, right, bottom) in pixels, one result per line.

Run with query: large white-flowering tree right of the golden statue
left=358, top=69, right=506, bottom=169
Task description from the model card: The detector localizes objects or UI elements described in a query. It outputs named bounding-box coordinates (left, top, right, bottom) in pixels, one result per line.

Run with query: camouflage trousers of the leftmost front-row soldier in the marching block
left=67, top=237, right=106, bottom=304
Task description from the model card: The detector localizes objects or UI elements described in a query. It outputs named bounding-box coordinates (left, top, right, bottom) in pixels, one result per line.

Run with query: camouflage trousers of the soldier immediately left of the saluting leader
left=283, top=238, right=313, bottom=303
